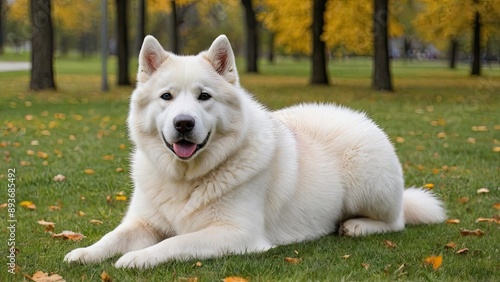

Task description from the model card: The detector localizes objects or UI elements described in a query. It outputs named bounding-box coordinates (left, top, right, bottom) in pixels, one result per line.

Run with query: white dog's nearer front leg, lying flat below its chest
left=115, top=226, right=272, bottom=268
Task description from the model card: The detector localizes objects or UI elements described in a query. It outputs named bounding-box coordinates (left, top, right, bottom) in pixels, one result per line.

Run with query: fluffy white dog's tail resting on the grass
left=403, top=187, right=446, bottom=224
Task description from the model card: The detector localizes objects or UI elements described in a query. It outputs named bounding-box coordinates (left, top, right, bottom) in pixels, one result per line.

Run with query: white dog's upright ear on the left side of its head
left=137, top=35, right=168, bottom=82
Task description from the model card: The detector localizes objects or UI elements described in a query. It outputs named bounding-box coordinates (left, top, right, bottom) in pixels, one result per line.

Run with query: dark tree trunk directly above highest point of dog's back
left=310, top=0, right=330, bottom=85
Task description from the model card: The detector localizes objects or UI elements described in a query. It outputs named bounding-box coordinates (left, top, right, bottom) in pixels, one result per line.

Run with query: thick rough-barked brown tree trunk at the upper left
left=30, top=0, right=56, bottom=90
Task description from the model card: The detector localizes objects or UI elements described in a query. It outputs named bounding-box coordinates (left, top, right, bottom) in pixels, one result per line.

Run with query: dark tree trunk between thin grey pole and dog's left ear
left=116, top=0, right=130, bottom=85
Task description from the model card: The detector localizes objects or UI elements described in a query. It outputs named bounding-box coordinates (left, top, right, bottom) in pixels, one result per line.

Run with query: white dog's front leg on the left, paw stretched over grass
left=64, top=216, right=160, bottom=264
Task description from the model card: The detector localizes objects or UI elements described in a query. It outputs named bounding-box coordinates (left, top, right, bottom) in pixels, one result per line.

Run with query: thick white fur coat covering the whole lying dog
left=65, top=35, right=445, bottom=268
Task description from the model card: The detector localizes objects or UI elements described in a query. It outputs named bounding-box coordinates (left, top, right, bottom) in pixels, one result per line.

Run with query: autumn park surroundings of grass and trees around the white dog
left=0, top=0, right=500, bottom=281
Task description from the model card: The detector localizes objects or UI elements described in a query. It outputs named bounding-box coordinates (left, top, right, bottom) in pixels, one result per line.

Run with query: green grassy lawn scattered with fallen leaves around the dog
left=0, top=55, right=500, bottom=281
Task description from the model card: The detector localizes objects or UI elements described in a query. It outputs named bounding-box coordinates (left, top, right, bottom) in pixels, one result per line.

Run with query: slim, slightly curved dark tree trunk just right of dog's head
left=241, top=0, right=259, bottom=73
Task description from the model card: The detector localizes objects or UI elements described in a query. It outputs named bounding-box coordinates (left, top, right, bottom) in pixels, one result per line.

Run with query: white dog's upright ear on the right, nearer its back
left=204, top=35, right=239, bottom=85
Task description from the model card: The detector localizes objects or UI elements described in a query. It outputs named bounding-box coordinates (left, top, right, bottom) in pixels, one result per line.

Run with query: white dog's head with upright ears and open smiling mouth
left=128, top=35, right=247, bottom=178
